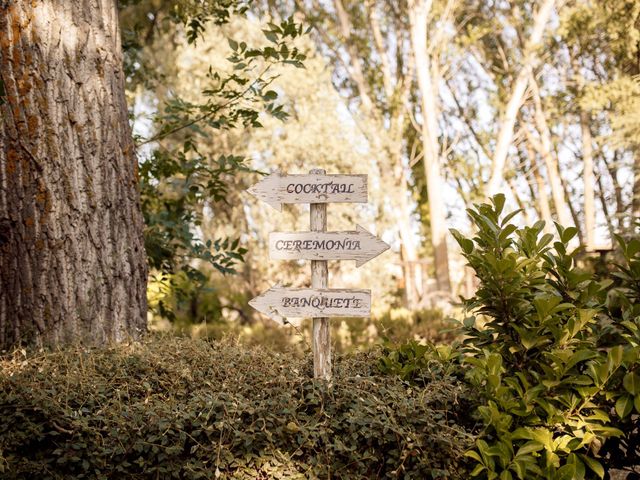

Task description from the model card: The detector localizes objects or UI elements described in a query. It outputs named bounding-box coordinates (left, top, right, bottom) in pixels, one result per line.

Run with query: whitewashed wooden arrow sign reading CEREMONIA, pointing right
left=269, top=225, right=389, bottom=267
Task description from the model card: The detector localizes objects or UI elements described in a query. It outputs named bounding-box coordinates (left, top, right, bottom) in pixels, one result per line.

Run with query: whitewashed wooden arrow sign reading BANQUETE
left=249, top=285, right=371, bottom=324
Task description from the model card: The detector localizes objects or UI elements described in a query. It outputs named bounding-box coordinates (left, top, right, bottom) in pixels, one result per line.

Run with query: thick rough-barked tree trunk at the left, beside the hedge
left=0, top=0, right=147, bottom=349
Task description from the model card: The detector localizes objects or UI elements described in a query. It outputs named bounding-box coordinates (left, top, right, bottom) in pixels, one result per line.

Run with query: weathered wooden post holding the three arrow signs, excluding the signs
left=309, top=169, right=331, bottom=381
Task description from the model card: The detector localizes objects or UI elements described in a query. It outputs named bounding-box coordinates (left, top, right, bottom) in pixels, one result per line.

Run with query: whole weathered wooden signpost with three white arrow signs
left=248, top=169, right=389, bottom=380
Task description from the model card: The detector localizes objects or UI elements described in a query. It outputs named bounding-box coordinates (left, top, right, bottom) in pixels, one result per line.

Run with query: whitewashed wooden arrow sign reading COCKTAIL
left=247, top=172, right=367, bottom=210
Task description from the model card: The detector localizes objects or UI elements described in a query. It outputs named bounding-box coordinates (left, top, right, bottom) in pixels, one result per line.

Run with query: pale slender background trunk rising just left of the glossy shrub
left=409, top=0, right=451, bottom=292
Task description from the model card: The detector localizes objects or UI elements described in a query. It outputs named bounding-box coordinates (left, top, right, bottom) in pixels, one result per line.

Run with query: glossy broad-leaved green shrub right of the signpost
left=453, top=195, right=640, bottom=480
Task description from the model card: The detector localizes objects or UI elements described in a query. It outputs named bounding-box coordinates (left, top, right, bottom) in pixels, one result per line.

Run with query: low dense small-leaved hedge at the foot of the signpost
left=0, top=337, right=473, bottom=479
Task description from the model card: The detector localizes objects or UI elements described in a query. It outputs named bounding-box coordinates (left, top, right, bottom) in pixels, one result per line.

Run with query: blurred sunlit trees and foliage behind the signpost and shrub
left=120, top=0, right=640, bottom=350
